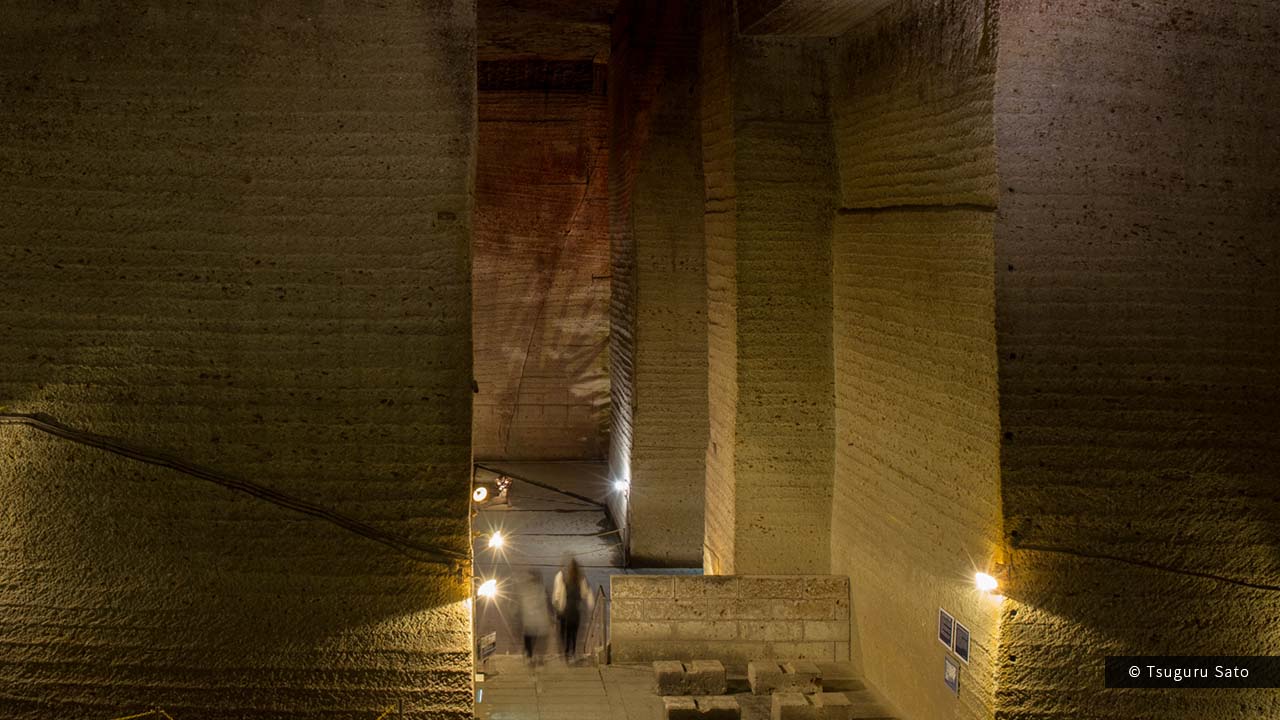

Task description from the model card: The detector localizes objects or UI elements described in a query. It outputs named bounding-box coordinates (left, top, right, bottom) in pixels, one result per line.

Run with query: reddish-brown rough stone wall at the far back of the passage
left=471, top=61, right=609, bottom=460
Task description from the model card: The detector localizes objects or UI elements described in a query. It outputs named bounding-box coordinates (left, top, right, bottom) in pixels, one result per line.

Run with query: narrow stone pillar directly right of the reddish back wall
left=609, top=3, right=707, bottom=566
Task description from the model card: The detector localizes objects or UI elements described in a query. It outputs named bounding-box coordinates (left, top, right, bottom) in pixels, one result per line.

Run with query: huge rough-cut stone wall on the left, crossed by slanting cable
left=0, top=1, right=475, bottom=720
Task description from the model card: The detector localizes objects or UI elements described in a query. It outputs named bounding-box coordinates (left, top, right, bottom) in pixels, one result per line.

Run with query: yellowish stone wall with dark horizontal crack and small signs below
left=831, top=0, right=1001, bottom=719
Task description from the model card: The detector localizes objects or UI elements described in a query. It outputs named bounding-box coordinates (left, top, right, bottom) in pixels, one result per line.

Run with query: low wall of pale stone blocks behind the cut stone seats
left=609, top=575, right=849, bottom=669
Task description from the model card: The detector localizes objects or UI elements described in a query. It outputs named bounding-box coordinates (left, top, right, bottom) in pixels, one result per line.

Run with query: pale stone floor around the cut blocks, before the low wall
left=475, top=655, right=893, bottom=720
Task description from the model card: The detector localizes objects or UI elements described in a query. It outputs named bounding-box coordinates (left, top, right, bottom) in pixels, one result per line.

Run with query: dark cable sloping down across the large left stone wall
left=0, top=413, right=471, bottom=565
